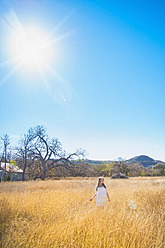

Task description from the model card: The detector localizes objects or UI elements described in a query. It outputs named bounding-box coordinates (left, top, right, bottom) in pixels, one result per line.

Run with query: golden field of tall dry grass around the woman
left=0, top=177, right=165, bottom=248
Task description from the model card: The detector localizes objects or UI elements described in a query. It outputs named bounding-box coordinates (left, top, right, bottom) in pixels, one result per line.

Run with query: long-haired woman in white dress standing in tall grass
left=90, top=177, right=110, bottom=207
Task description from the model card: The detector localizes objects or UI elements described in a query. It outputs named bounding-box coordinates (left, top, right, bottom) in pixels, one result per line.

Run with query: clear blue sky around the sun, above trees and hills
left=0, top=0, right=165, bottom=161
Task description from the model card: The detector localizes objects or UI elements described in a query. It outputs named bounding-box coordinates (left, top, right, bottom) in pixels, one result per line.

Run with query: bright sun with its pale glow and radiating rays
left=0, top=11, right=74, bottom=102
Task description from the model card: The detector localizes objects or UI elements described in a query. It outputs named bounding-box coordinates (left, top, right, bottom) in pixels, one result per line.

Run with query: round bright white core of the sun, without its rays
left=9, top=27, right=54, bottom=70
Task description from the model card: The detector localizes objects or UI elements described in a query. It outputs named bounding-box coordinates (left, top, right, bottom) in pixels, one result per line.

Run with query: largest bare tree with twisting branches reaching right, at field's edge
left=30, top=126, right=84, bottom=180
